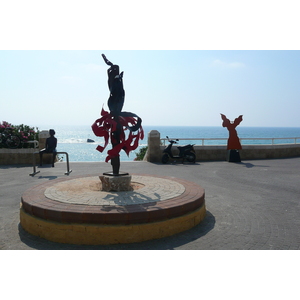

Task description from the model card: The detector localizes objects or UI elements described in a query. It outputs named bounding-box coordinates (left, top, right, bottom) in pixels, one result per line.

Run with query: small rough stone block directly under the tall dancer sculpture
left=99, top=174, right=132, bottom=192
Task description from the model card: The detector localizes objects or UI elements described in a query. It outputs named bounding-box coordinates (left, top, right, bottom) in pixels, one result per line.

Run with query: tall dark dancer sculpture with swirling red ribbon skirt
left=92, top=54, right=144, bottom=176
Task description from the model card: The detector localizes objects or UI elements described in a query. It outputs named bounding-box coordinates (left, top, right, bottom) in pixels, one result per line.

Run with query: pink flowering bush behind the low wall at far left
left=0, top=121, right=39, bottom=148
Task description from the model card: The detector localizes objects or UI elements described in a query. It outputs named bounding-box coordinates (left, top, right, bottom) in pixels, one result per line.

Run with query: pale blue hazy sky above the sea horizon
left=0, top=50, right=300, bottom=127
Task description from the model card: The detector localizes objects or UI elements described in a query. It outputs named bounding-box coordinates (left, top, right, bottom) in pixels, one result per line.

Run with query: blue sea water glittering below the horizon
left=39, top=125, right=300, bottom=162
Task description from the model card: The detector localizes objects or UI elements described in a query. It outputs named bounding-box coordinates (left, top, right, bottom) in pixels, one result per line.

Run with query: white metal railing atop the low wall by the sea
left=160, top=137, right=300, bottom=146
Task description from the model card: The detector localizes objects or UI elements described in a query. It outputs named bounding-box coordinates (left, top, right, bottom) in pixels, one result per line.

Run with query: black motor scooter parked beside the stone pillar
left=161, top=136, right=196, bottom=164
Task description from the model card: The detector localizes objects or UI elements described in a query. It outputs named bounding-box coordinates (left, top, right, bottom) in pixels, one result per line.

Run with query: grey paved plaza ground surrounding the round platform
left=0, top=157, right=300, bottom=250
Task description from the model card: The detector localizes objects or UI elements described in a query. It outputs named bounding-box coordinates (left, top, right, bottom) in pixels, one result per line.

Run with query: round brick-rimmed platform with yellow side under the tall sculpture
left=20, top=175, right=206, bottom=245
